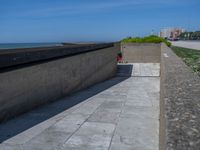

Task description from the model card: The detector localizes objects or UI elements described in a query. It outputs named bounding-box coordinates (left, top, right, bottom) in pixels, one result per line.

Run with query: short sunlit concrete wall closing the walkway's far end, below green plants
left=121, top=43, right=160, bottom=63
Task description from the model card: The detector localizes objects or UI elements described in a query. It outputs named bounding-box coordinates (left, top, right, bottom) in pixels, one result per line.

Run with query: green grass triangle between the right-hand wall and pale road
left=171, top=46, right=200, bottom=76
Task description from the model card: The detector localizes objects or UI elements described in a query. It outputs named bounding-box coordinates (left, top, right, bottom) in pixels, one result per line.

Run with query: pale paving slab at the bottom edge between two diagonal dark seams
left=61, top=122, right=115, bottom=150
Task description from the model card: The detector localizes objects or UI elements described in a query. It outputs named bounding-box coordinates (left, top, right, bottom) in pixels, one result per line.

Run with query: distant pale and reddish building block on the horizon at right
left=160, top=28, right=185, bottom=40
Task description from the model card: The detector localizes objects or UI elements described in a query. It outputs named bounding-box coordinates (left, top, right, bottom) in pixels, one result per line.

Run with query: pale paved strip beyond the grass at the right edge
left=172, top=41, right=200, bottom=50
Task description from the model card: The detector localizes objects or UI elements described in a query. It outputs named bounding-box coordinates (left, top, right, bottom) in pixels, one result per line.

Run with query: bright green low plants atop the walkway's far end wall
left=121, top=35, right=171, bottom=46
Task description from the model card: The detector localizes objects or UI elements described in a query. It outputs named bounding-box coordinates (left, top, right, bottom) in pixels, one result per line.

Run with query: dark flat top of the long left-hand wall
left=0, top=43, right=114, bottom=69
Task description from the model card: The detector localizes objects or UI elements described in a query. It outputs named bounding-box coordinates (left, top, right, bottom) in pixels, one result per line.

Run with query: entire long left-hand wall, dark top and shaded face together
left=0, top=44, right=120, bottom=121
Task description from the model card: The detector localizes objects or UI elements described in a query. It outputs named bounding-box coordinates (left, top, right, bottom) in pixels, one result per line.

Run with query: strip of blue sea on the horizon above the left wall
left=0, top=43, right=62, bottom=50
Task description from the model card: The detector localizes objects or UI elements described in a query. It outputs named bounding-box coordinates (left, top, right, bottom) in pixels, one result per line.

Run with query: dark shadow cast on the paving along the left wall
left=0, top=65, right=132, bottom=143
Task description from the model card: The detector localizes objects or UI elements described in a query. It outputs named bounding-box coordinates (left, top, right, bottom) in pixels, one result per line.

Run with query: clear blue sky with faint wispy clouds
left=0, top=0, right=200, bottom=43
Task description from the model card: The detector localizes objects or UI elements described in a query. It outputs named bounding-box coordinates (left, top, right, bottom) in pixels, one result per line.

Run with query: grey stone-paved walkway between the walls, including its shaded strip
left=0, top=64, right=160, bottom=150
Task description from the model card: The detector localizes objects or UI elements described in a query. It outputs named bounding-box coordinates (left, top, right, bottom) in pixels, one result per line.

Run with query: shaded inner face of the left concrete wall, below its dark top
left=0, top=44, right=120, bottom=121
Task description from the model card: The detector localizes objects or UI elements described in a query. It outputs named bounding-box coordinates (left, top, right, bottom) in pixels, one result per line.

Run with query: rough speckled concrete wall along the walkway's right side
left=160, top=44, right=200, bottom=150
